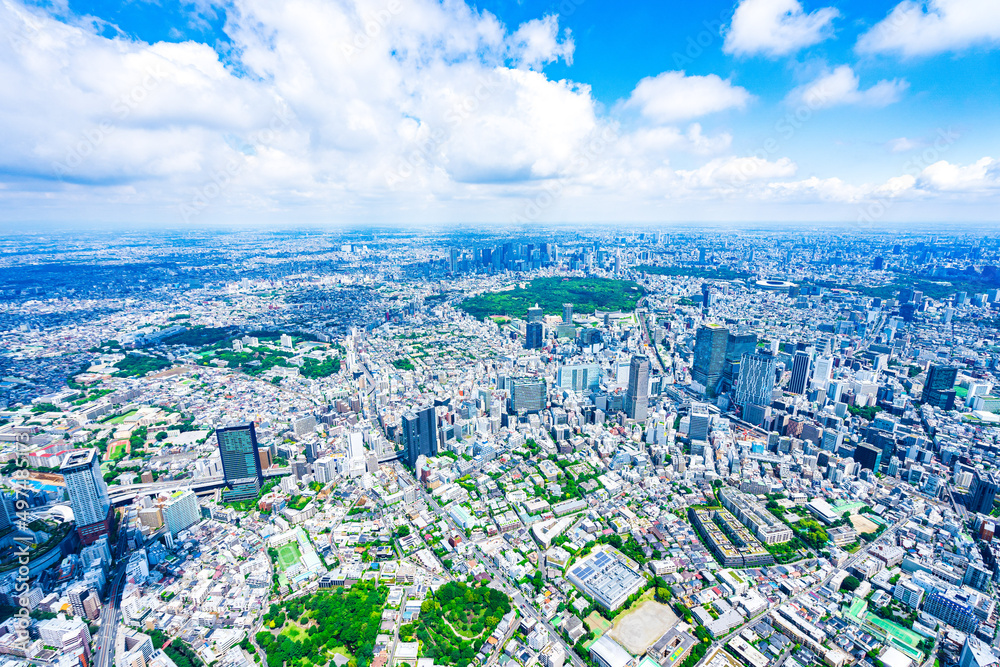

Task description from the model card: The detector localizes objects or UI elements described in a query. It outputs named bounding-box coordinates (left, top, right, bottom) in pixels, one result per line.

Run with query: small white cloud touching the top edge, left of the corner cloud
left=722, top=0, right=840, bottom=57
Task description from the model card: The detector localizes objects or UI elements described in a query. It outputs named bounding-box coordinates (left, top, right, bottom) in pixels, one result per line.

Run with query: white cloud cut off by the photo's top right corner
left=856, top=0, right=1000, bottom=56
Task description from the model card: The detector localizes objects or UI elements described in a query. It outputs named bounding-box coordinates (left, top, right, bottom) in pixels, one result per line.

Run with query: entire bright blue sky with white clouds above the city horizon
left=0, top=0, right=1000, bottom=225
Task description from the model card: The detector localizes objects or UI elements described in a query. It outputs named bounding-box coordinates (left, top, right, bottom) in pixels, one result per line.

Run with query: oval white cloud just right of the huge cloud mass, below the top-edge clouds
left=624, top=71, right=751, bottom=123
